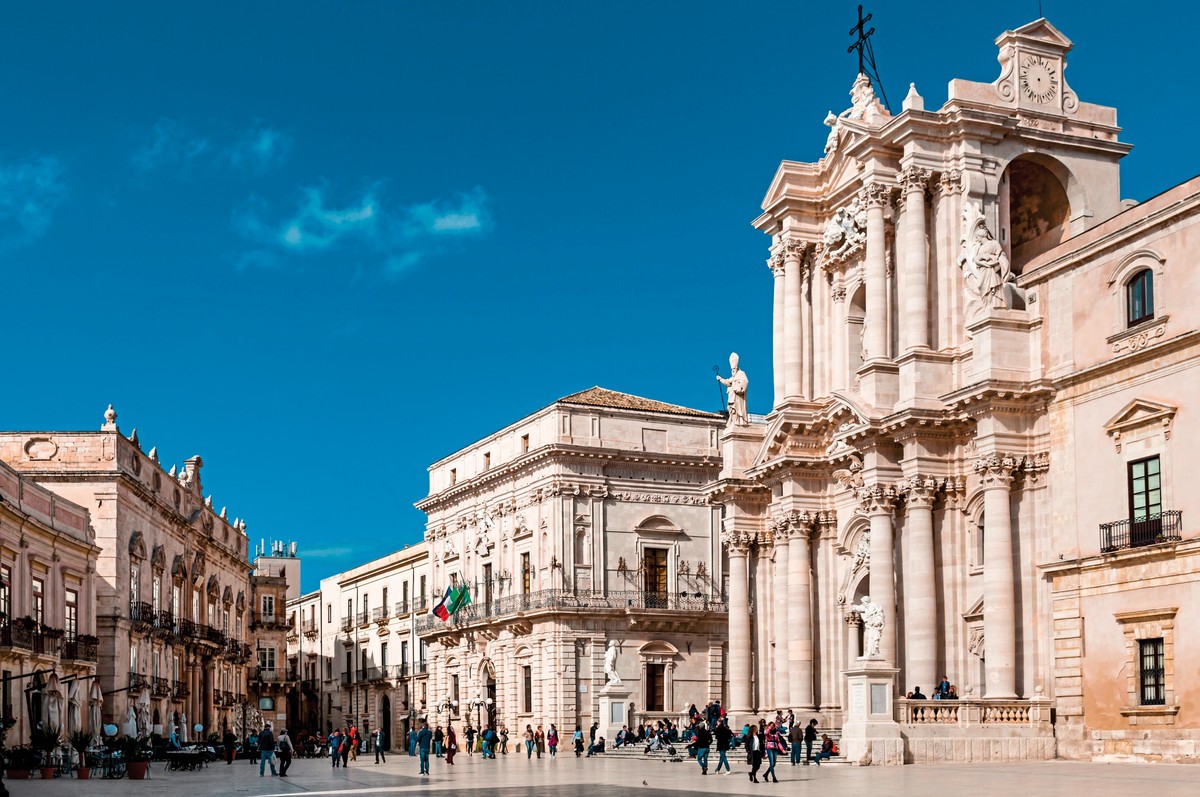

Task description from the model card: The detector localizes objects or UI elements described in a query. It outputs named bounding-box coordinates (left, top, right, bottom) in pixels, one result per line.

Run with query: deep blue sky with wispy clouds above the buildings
left=0, top=0, right=1200, bottom=588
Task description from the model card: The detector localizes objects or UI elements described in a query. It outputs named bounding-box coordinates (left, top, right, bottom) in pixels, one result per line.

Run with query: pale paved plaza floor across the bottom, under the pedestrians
left=5, top=755, right=1200, bottom=797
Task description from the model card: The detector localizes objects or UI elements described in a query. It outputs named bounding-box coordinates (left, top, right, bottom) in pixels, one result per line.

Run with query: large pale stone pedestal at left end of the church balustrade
left=841, top=659, right=904, bottom=766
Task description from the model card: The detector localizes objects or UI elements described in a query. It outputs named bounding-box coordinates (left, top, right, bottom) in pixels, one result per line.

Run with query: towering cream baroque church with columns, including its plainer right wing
left=712, top=19, right=1200, bottom=763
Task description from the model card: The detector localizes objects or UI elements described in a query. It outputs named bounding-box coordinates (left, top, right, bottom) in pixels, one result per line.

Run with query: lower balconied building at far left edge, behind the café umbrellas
left=0, top=462, right=100, bottom=747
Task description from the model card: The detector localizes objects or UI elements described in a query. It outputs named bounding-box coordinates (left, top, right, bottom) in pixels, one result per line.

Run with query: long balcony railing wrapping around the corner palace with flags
left=416, top=589, right=728, bottom=633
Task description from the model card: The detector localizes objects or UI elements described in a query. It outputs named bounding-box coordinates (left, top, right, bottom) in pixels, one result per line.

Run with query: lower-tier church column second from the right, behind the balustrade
left=900, top=477, right=938, bottom=694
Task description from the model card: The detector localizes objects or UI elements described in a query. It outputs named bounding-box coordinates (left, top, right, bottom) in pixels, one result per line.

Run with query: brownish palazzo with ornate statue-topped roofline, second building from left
left=0, top=407, right=252, bottom=735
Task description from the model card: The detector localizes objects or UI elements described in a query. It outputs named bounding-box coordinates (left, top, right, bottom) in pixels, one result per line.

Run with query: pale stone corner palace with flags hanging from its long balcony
left=416, top=388, right=727, bottom=738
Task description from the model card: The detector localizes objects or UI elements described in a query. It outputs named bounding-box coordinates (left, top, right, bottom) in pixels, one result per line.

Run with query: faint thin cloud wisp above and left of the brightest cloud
left=133, top=118, right=292, bottom=174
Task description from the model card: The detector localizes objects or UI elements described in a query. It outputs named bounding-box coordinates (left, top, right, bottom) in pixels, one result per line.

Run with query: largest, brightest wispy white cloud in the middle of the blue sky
left=234, top=186, right=490, bottom=277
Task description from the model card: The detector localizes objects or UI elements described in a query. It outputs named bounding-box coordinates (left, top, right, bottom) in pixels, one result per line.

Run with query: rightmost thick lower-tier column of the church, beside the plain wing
left=974, top=454, right=1016, bottom=697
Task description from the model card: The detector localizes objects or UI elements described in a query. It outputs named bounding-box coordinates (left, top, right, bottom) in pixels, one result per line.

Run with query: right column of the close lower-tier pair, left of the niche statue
left=787, top=513, right=814, bottom=712
